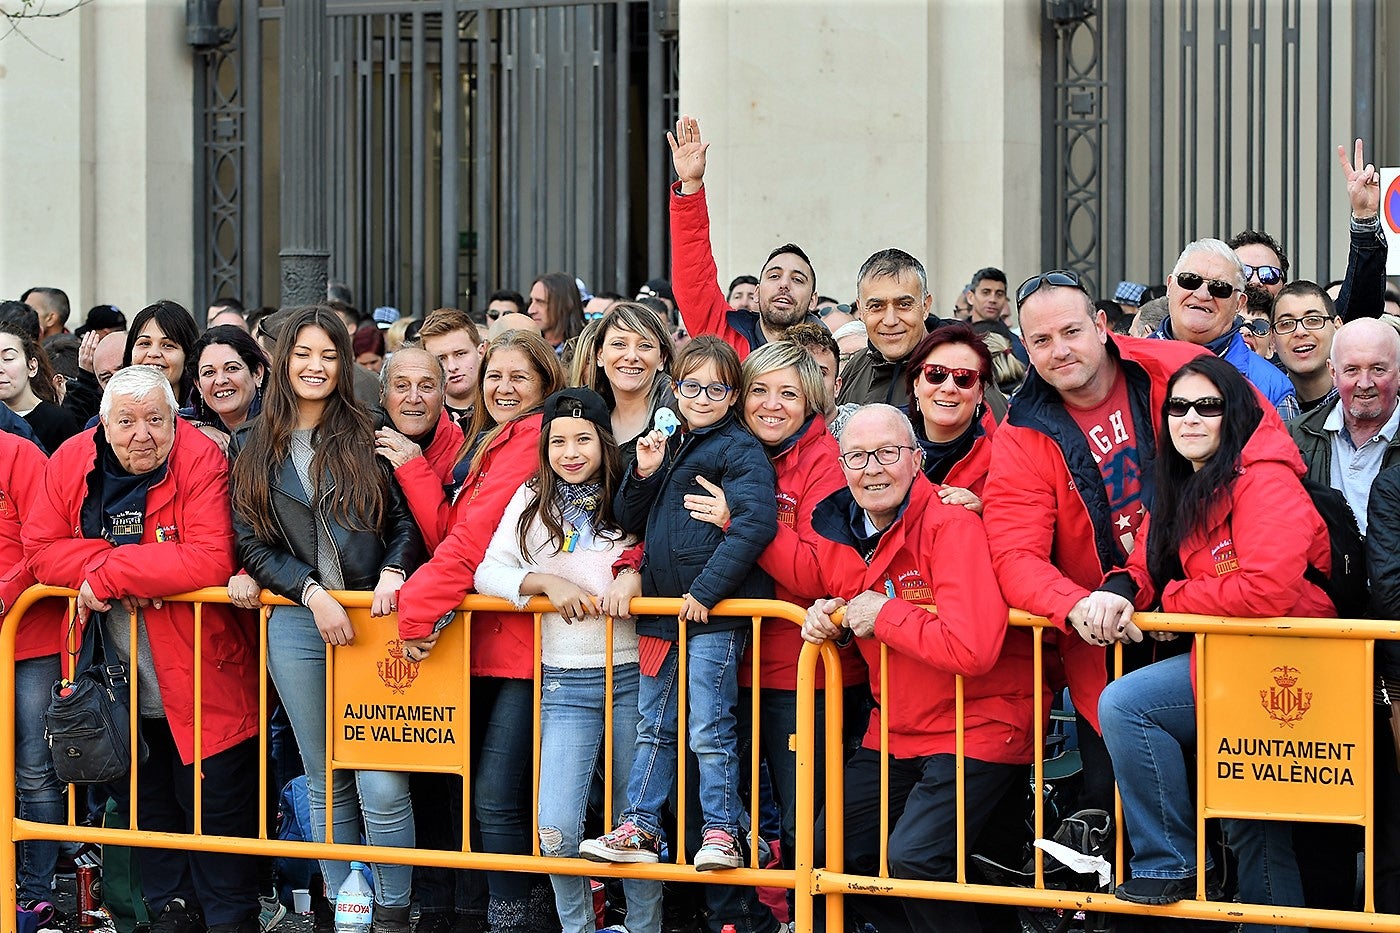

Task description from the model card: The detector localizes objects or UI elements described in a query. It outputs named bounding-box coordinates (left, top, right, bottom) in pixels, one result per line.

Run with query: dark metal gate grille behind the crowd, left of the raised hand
left=196, top=0, right=676, bottom=315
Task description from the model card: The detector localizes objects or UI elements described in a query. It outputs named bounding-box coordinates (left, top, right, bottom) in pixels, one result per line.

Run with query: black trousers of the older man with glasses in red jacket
left=815, top=748, right=1025, bottom=933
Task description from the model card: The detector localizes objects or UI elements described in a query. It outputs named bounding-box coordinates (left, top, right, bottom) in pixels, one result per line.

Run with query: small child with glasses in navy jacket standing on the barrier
left=580, top=336, right=777, bottom=871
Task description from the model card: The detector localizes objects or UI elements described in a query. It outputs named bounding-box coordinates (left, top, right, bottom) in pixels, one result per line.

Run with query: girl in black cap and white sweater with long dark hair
left=476, top=388, right=661, bottom=933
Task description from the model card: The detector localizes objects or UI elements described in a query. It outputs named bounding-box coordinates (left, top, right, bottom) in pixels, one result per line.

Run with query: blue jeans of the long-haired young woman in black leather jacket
left=267, top=605, right=414, bottom=906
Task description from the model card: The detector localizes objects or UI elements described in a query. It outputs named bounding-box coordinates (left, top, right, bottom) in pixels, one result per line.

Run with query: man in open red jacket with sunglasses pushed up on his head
left=983, top=264, right=1204, bottom=811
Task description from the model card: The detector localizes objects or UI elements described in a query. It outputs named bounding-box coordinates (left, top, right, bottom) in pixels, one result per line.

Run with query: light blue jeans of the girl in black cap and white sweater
left=539, top=664, right=661, bottom=933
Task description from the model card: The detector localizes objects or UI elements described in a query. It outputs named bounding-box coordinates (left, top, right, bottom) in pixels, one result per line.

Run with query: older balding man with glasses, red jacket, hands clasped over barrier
left=773, top=405, right=1035, bottom=932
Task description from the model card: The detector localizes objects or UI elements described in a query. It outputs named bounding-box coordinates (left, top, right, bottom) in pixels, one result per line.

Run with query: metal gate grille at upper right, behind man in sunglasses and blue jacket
left=1042, top=0, right=1376, bottom=291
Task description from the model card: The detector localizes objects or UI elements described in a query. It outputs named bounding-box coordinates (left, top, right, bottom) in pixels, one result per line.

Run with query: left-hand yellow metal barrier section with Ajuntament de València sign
left=0, top=587, right=841, bottom=933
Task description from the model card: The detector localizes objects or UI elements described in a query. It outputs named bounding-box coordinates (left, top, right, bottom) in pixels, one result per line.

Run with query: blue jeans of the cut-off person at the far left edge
left=14, top=654, right=67, bottom=901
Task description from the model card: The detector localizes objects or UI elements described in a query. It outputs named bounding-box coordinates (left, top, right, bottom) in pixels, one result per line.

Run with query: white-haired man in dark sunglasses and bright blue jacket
left=1152, top=238, right=1298, bottom=422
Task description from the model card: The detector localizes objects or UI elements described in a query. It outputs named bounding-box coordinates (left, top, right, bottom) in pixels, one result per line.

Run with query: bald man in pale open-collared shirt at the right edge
left=1288, top=318, right=1400, bottom=534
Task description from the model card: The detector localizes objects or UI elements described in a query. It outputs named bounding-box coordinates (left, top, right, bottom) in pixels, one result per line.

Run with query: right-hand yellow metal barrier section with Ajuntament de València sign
left=798, top=609, right=1400, bottom=933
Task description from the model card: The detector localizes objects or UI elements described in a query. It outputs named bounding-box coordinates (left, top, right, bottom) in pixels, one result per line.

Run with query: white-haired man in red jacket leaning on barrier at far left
left=21, top=366, right=259, bottom=933
